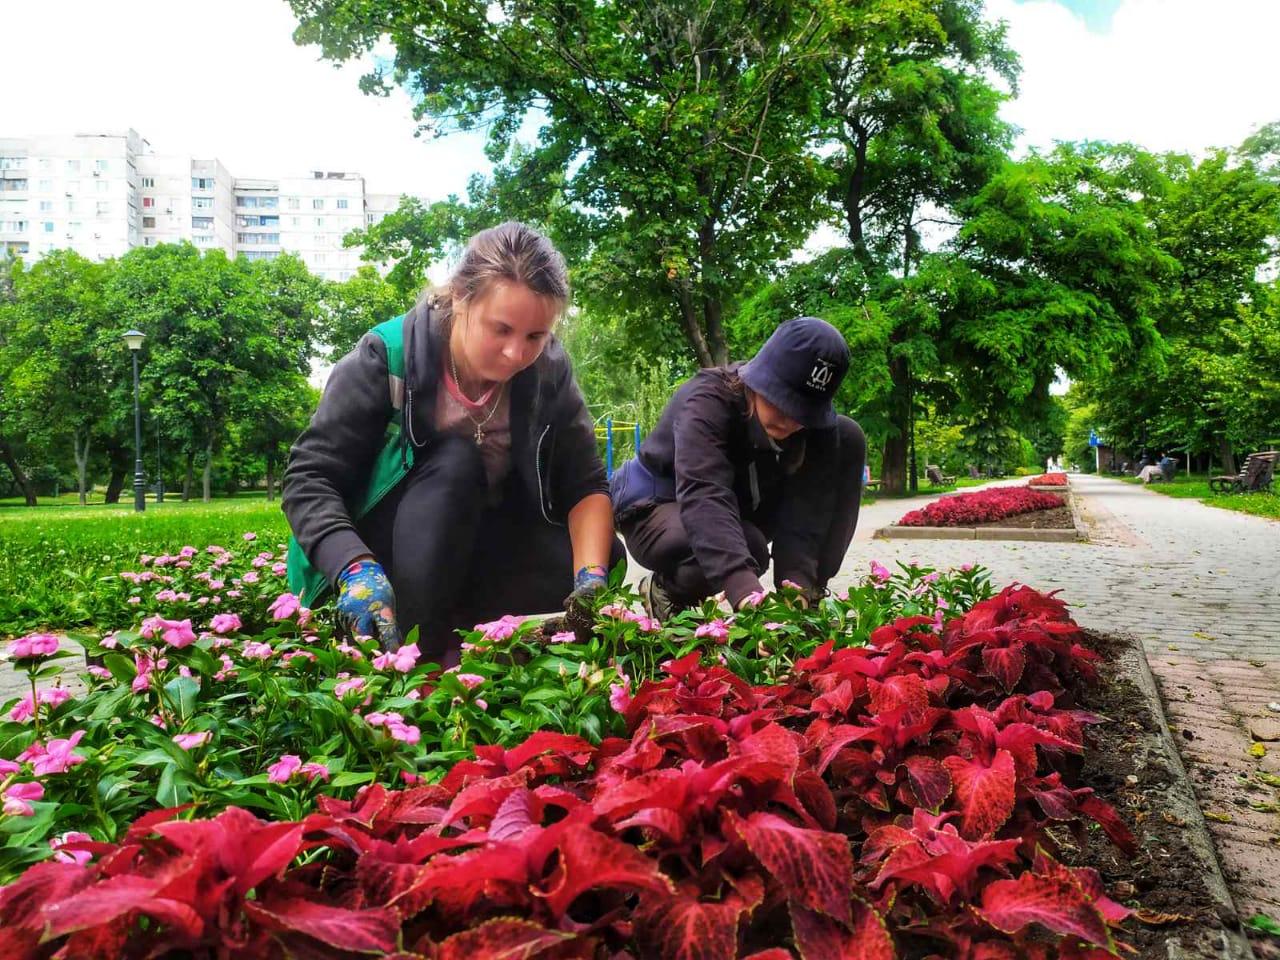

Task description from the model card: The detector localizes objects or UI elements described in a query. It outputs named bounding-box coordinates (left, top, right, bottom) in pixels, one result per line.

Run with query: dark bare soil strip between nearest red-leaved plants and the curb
left=1061, top=634, right=1234, bottom=960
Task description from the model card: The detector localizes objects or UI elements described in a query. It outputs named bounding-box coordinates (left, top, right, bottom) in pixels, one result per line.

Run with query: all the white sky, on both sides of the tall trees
left=0, top=0, right=1280, bottom=200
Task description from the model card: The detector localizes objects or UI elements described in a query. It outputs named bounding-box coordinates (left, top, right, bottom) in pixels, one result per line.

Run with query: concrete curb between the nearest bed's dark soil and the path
left=1124, top=637, right=1257, bottom=960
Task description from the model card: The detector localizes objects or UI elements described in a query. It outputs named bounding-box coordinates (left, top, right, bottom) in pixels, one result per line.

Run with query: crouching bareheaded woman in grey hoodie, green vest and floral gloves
left=283, top=223, right=623, bottom=662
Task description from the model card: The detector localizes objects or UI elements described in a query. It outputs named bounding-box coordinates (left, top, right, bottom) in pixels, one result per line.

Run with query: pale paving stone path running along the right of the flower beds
left=833, top=475, right=1280, bottom=956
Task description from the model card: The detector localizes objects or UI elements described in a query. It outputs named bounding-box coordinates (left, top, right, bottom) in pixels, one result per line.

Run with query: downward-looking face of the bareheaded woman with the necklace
left=453, top=280, right=559, bottom=383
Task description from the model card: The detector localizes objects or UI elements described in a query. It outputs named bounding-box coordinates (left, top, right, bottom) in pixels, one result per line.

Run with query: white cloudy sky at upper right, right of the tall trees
left=987, top=0, right=1280, bottom=152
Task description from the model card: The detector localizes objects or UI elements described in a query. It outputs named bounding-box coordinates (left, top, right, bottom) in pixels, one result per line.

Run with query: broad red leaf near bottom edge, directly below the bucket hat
left=733, top=813, right=854, bottom=923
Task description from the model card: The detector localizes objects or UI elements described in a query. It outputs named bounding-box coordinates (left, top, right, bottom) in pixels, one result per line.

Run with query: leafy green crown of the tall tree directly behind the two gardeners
left=291, top=0, right=844, bottom=365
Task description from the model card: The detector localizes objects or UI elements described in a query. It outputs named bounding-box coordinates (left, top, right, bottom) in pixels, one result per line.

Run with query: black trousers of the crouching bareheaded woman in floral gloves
left=357, top=434, right=626, bottom=666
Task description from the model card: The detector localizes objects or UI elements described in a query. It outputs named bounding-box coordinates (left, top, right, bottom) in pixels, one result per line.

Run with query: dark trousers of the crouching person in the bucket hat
left=622, top=417, right=867, bottom=604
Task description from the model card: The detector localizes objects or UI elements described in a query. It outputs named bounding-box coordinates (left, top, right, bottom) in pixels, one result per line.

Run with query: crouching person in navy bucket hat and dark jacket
left=609, top=316, right=867, bottom=620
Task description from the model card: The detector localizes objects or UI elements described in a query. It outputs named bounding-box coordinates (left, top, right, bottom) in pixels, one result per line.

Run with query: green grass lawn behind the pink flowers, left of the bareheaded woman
left=0, top=494, right=288, bottom=637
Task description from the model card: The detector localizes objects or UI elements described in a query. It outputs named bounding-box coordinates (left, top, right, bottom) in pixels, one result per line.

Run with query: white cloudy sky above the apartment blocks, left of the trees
left=0, top=0, right=488, bottom=200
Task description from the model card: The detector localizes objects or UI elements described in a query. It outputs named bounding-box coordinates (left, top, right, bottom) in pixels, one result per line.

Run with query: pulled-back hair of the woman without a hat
left=419, top=220, right=570, bottom=321
